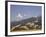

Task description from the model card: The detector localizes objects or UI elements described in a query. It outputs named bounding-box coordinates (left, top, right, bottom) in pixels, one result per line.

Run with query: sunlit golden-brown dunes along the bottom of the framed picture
left=11, top=22, right=41, bottom=32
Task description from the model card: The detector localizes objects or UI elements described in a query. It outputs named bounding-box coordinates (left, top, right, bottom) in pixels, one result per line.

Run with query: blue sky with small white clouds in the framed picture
left=10, top=5, right=42, bottom=21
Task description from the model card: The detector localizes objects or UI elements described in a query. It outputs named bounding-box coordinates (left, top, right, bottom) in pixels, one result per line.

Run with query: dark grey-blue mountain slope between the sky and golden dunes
left=11, top=16, right=42, bottom=27
